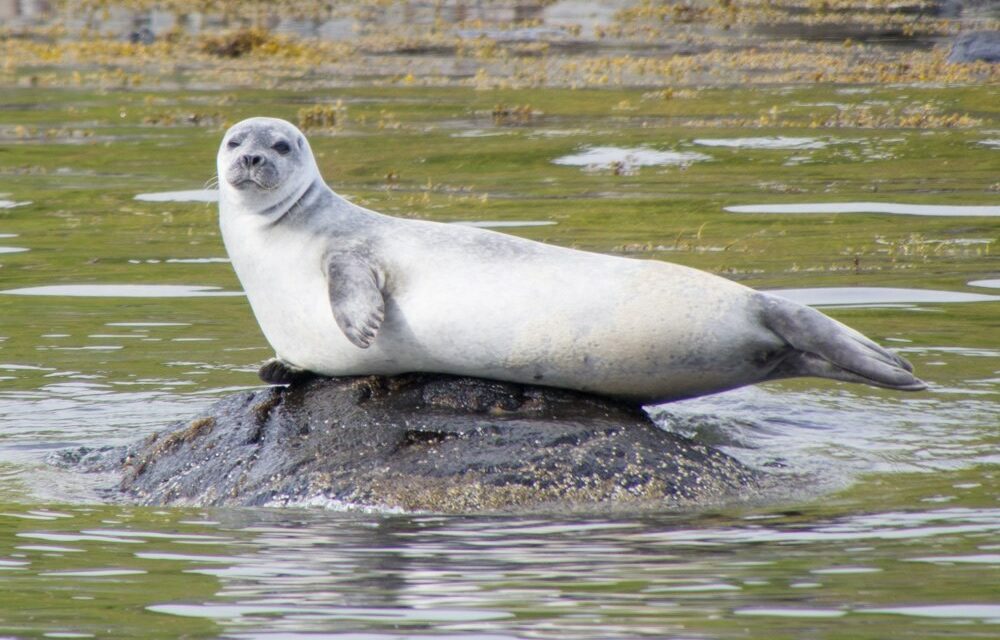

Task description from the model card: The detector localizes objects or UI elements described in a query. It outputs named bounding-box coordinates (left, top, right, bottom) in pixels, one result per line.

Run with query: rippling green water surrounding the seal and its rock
left=0, top=86, right=1000, bottom=639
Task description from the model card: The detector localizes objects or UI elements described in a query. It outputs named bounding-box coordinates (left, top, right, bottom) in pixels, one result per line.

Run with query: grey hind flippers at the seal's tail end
left=759, top=293, right=927, bottom=391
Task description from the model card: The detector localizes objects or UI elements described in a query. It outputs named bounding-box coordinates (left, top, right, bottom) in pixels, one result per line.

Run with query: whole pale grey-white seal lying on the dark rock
left=218, top=118, right=925, bottom=404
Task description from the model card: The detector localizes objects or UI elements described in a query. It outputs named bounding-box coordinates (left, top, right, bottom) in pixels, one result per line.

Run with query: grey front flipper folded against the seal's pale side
left=326, top=252, right=385, bottom=349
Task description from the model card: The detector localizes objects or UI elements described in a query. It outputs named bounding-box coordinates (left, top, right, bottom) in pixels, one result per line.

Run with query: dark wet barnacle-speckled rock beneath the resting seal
left=62, top=374, right=757, bottom=512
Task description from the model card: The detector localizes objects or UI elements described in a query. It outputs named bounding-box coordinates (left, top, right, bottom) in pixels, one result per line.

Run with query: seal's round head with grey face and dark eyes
left=217, top=118, right=319, bottom=213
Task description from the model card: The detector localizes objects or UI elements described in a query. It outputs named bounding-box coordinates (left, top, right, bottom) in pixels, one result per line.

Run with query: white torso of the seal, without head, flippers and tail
left=227, top=222, right=778, bottom=397
